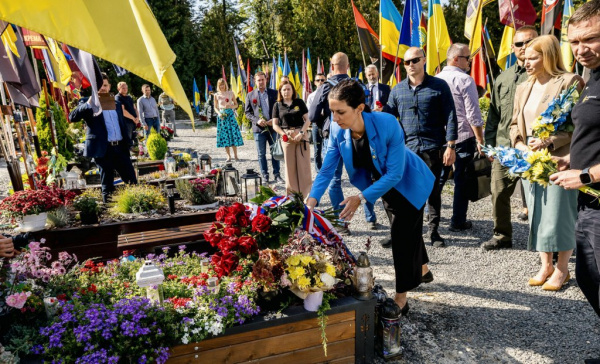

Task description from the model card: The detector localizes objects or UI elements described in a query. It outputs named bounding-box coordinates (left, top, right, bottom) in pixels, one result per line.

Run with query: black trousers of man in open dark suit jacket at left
left=94, top=144, right=137, bottom=203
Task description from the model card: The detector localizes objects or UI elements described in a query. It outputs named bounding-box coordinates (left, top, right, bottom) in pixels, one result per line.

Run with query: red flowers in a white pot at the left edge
left=0, top=187, right=75, bottom=232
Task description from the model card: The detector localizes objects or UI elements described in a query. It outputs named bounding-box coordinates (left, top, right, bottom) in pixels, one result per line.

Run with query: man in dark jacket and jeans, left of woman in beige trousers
left=244, top=71, right=284, bottom=183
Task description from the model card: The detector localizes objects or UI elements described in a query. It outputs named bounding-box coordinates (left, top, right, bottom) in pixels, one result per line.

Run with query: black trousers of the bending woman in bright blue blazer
left=381, top=188, right=429, bottom=293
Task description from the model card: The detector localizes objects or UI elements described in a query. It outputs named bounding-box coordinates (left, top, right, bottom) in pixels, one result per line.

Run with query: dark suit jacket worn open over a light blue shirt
left=69, top=98, right=131, bottom=158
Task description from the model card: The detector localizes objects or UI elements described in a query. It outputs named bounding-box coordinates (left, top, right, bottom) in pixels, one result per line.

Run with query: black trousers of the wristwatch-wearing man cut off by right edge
left=575, top=207, right=600, bottom=316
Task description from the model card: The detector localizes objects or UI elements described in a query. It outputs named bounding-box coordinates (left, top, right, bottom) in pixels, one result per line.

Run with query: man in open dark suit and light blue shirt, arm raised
left=69, top=73, right=137, bottom=202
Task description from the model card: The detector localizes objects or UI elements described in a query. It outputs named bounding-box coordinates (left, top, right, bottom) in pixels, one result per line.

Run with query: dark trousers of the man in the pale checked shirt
left=440, top=137, right=477, bottom=226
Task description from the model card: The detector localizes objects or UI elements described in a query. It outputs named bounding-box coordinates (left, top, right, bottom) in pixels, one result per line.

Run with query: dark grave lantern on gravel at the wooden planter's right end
left=376, top=298, right=402, bottom=360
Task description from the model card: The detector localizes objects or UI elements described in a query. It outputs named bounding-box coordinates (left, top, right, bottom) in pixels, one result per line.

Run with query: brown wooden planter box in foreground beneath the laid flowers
left=168, top=297, right=376, bottom=364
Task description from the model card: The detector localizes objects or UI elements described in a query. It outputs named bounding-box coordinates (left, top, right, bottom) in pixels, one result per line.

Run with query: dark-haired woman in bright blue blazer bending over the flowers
left=306, top=80, right=434, bottom=314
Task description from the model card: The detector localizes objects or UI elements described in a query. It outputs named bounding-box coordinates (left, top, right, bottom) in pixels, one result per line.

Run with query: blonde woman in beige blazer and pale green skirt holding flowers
left=510, top=35, right=584, bottom=291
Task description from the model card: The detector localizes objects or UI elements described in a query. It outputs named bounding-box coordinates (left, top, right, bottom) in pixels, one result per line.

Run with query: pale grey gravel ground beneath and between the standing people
left=0, top=121, right=600, bottom=363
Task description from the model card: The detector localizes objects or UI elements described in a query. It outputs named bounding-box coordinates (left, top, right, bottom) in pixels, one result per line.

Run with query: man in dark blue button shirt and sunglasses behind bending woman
left=384, top=47, right=458, bottom=247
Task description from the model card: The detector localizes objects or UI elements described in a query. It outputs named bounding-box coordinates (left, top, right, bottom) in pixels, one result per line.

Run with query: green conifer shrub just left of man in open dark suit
left=35, top=92, right=73, bottom=161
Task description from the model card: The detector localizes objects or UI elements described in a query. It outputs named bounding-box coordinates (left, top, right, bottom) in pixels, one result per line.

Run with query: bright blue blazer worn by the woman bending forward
left=309, top=112, right=435, bottom=209
